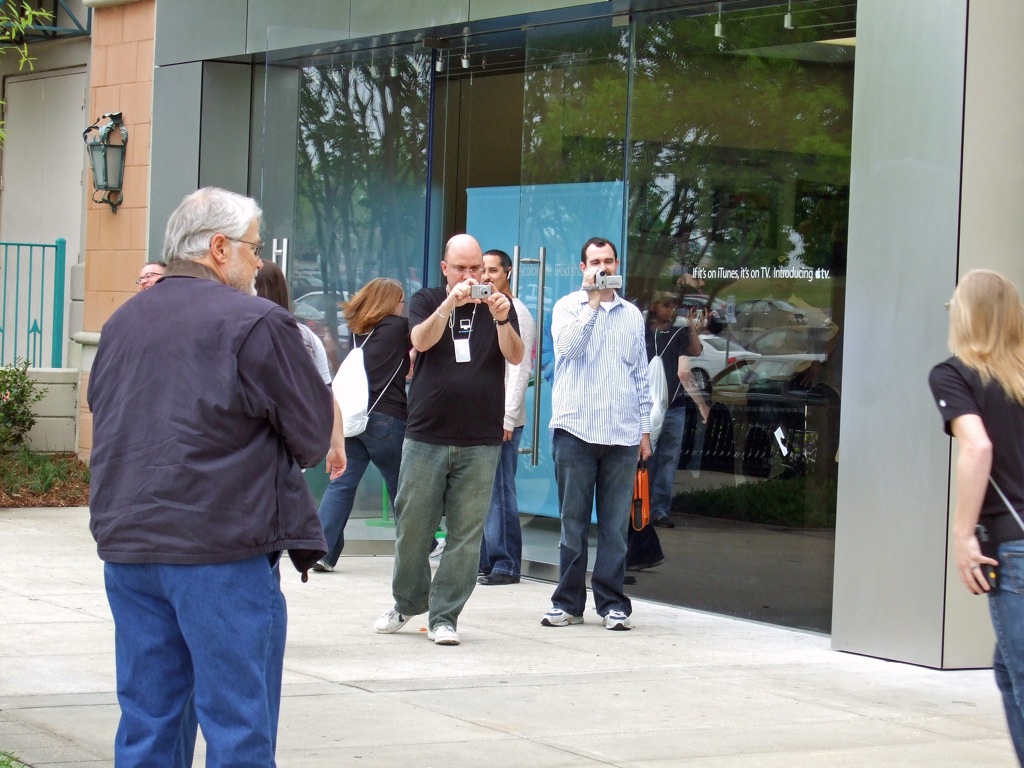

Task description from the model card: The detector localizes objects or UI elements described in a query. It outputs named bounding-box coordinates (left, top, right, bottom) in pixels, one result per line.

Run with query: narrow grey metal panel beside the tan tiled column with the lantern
left=148, top=61, right=203, bottom=258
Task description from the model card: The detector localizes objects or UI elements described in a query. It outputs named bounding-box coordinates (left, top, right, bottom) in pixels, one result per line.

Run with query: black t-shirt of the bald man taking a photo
left=406, top=288, right=519, bottom=445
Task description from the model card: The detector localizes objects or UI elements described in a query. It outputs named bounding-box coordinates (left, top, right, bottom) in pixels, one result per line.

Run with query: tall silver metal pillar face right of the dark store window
left=833, top=0, right=974, bottom=667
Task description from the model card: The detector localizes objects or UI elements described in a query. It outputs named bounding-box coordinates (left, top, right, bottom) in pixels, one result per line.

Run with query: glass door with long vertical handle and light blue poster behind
left=466, top=17, right=629, bottom=517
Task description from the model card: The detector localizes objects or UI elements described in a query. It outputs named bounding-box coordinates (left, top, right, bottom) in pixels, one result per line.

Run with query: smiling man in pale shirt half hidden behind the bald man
left=476, top=249, right=535, bottom=586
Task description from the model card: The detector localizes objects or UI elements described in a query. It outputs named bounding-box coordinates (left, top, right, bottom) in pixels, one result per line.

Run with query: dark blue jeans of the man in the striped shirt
left=551, top=429, right=639, bottom=616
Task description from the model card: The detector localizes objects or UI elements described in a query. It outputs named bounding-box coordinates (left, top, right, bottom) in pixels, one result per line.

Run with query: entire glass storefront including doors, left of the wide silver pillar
left=254, top=0, right=856, bottom=631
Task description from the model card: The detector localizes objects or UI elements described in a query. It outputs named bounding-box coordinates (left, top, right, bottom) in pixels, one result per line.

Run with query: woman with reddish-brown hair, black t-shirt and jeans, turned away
left=313, top=278, right=412, bottom=572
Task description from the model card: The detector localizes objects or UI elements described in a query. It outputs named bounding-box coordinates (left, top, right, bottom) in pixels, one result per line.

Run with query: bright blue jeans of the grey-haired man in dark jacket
left=103, top=555, right=288, bottom=768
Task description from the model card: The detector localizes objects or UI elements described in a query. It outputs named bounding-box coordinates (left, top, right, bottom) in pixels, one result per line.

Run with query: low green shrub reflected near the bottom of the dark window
left=674, top=477, right=837, bottom=528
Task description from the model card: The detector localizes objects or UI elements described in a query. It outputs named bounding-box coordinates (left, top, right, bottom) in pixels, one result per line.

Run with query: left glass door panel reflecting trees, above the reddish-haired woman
left=256, top=28, right=432, bottom=519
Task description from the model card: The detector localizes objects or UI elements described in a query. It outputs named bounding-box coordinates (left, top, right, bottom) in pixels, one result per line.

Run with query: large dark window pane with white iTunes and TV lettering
left=627, top=0, right=856, bottom=630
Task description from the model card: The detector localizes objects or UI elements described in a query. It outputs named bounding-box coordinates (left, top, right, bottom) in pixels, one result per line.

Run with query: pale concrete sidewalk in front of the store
left=0, top=508, right=1017, bottom=768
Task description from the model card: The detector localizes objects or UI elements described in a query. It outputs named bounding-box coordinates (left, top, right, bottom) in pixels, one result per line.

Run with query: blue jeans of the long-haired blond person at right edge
left=988, top=540, right=1024, bottom=765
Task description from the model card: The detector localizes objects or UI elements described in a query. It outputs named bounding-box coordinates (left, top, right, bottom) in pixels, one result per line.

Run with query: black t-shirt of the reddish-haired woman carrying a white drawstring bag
left=354, top=314, right=413, bottom=421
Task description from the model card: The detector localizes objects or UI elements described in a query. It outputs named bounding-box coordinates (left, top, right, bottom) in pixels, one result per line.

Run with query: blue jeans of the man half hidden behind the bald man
left=480, top=427, right=522, bottom=575
